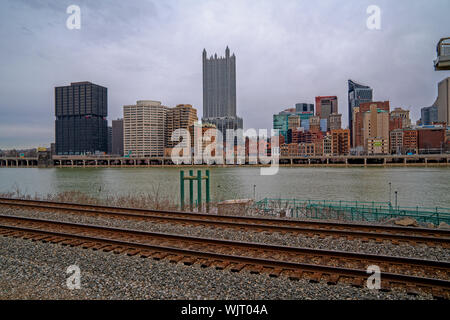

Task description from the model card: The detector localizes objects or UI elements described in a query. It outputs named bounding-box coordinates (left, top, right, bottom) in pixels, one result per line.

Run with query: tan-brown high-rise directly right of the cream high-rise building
left=165, top=104, right=198, bottom=148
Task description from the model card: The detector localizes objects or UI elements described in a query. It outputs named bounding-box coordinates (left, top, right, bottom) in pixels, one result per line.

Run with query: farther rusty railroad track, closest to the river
left=0, top=198, right=450, bottom=248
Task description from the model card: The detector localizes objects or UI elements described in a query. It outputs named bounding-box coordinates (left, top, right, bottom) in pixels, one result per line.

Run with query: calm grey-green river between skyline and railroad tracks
left=0, top=167, right=450, bottom=207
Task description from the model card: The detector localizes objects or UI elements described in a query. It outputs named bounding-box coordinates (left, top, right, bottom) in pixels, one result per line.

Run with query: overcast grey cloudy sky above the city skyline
left=0, top=0, right=450, bottom=148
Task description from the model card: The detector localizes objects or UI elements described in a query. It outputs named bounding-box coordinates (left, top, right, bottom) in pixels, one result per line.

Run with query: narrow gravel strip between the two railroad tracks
left=0, top=208, right=450, bottom=261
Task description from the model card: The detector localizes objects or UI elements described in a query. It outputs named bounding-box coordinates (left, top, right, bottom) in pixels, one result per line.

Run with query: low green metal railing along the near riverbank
left=254, top=198, right=450, bottom=225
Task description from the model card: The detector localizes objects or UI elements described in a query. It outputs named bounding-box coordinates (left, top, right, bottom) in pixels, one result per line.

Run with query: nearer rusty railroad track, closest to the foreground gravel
left=0, top=216, right=450, bottom=299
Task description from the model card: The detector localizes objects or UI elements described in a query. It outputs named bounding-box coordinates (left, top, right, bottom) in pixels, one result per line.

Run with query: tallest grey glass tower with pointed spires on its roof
left=202, top=47, right=243, bottom=134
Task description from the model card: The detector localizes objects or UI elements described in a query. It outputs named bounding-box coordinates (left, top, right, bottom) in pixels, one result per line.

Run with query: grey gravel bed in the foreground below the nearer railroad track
left=0, top=237, right=432, bottom=300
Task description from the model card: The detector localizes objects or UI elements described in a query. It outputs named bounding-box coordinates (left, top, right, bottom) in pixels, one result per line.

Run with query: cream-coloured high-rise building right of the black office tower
left=123, top=100, right=167, bottom=157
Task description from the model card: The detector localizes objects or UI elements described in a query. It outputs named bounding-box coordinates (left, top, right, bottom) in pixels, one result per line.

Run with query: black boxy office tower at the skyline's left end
left=55, top=82, right=108, bottom=155
